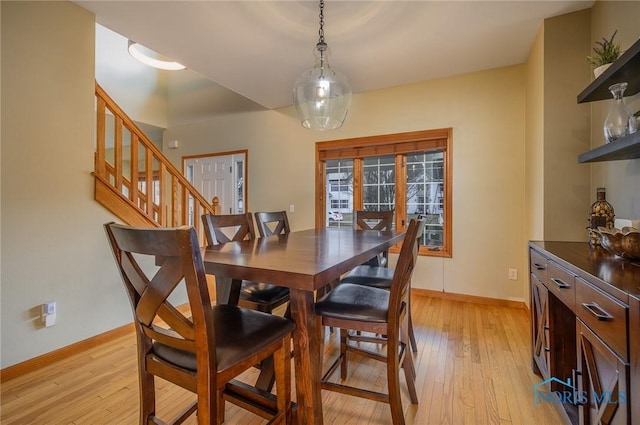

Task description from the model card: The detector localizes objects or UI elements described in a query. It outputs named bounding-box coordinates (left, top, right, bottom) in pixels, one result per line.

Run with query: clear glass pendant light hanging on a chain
left=293, top=0, right=351, bottom=131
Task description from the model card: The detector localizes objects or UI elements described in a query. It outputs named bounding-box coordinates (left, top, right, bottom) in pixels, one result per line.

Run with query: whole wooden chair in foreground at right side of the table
left=315, top=220, right=424, bottom=425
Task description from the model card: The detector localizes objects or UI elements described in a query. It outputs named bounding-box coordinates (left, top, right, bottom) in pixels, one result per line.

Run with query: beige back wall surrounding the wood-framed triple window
left=165, top=65, right=527, bottom=300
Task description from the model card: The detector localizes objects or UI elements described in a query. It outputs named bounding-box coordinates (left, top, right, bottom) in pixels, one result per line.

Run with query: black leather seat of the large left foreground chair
left=153, top=304, right=295, bottom=372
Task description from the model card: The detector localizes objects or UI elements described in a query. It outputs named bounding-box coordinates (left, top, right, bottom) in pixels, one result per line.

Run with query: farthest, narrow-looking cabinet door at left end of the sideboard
left=531, top=274, right=549, bottom=379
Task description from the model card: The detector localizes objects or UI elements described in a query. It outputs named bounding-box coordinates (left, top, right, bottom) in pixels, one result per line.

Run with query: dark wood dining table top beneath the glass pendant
left=203, top=228, right=404, bottom=291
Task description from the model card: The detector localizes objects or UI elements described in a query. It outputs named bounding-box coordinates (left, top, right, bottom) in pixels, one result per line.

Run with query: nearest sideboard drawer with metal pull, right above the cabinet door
left=575, top=277, right=629, bottom=362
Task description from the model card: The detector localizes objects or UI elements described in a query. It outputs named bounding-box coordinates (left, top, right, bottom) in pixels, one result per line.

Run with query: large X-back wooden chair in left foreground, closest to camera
left=105, top=223, right=295, bottom=425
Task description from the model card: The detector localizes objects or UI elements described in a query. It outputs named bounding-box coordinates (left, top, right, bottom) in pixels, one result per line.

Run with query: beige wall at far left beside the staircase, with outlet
left=0, top=1, right=131, bottom=367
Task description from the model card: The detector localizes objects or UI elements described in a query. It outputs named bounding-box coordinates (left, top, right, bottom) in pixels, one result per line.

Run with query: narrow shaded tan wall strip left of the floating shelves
left=543, top=10, right=590, bottom=241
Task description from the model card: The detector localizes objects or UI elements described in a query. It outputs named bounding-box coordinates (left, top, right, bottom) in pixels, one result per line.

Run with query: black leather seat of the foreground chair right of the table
left=316, top=283, right=389, bottom=323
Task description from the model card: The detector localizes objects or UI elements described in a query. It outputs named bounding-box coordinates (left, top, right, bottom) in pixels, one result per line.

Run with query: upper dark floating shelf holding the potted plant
left=578, top=40, right=640, bottom=103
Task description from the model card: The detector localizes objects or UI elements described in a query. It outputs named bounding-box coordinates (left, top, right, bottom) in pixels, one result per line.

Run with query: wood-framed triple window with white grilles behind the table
left=316, top=129, right=453, bottom=257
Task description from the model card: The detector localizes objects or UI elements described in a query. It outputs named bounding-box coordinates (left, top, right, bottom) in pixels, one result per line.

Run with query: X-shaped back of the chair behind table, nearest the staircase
left=202, top=213, right=256, bottom=246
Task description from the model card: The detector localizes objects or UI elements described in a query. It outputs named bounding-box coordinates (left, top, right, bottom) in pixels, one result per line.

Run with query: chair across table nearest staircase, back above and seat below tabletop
left=202, top=213, right=289, bottom=313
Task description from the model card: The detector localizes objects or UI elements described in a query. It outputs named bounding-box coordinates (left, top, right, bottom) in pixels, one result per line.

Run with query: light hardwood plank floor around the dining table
left=0, top=295, right=562, bottom=425
